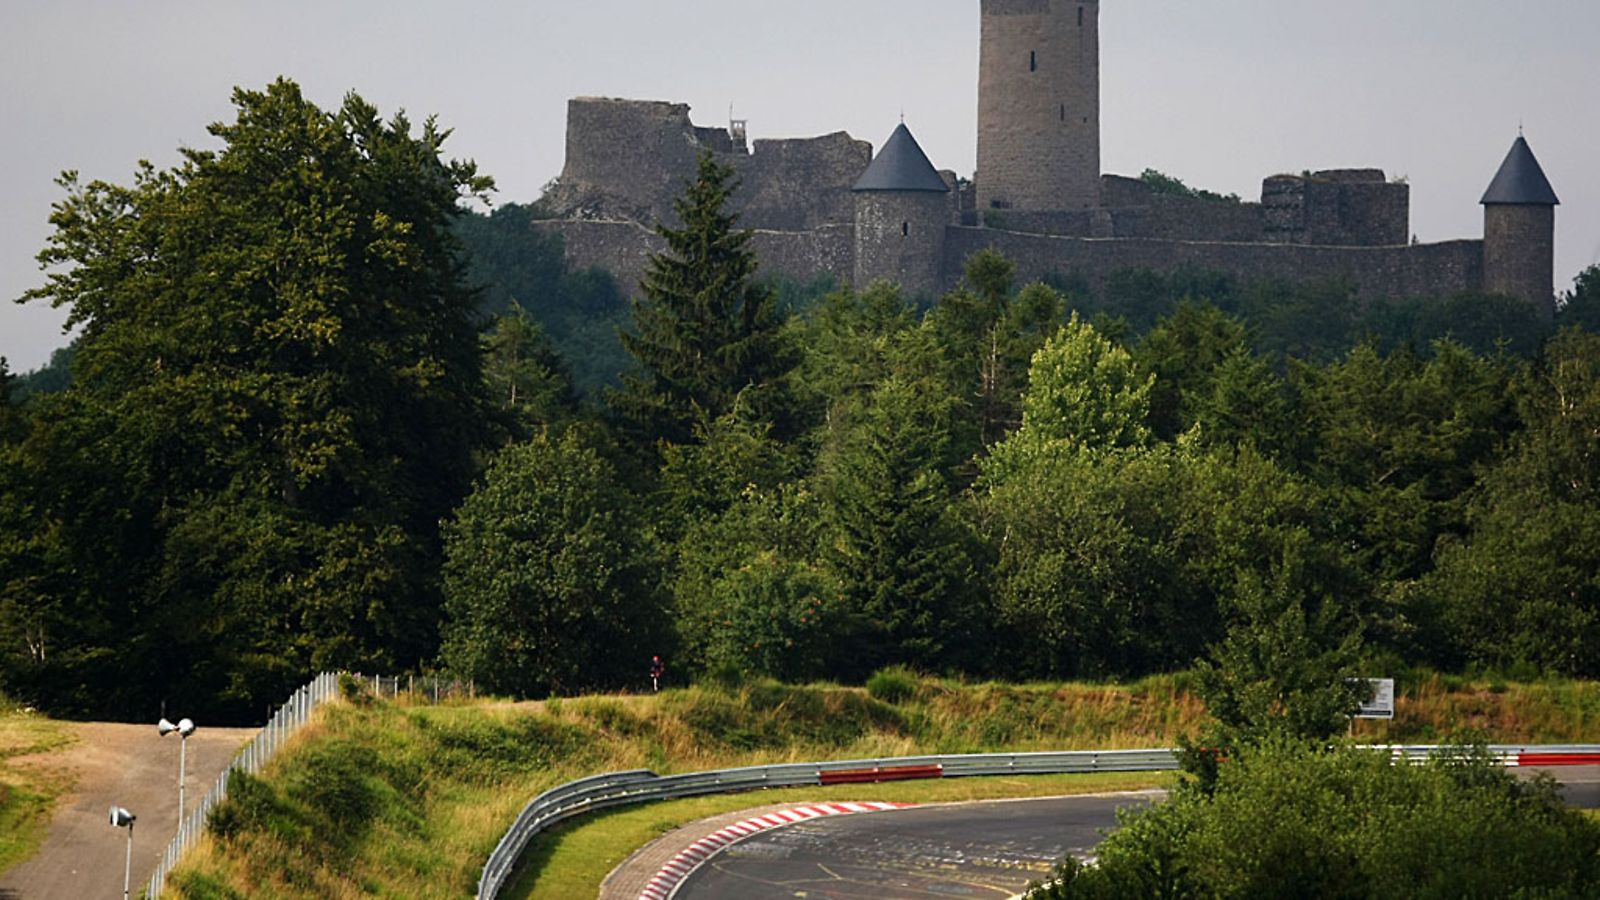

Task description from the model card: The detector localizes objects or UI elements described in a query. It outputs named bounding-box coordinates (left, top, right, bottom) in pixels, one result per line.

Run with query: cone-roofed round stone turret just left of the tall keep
left=851, top=123, right=950, bottom=296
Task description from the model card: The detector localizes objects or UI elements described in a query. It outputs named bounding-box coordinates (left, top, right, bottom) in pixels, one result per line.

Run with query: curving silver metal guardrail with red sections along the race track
left=477, top=745, right=1600, bottom=900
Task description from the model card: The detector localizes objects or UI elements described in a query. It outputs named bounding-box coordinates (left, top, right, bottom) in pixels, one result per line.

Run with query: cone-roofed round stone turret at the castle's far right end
left=1483, top=136, right=1560, bottom=315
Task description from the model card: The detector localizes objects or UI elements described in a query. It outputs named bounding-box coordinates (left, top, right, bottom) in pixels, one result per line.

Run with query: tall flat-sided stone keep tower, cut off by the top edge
left=978, top=0, right=1101, bottom=211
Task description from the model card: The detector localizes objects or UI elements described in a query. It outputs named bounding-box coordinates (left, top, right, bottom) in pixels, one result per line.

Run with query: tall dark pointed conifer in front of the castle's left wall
left=610, top=154, right=794, bottom=445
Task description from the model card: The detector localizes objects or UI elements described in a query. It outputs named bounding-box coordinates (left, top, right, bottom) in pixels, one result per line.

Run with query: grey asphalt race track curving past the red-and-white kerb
left=674, top=765, right=1600, bottom=900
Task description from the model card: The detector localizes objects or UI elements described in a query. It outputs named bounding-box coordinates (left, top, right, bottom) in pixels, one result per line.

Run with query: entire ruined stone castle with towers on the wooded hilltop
left=539, top=0, right=1558, bottom=314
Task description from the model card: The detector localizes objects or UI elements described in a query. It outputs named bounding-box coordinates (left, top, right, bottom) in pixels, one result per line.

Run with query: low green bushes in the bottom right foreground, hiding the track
left=1029, top=741, right=1600, bottom=900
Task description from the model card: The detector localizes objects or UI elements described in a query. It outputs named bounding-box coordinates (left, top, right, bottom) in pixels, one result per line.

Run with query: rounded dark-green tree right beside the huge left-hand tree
left=440, top=431, right=651, bottom=697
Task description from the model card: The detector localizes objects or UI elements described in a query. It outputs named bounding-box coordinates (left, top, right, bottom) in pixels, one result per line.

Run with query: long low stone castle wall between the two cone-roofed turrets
left=944, top=227, right=1483, bottom=296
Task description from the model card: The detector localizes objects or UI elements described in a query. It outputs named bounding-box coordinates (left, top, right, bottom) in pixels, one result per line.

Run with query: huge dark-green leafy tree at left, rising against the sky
left=0, top=80, right=490, bottom=717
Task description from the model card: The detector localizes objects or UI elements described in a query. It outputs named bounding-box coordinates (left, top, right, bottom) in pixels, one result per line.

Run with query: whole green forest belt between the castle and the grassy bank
left=0, top=80, right=1600, bottom=721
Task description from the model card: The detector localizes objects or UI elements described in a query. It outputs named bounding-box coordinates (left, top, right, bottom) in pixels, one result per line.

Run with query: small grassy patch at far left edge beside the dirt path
left=0, top=697, right=75, bottom=871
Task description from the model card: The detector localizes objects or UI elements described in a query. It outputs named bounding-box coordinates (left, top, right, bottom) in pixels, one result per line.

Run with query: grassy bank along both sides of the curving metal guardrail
left=159, top=676, right=1600, bottom=898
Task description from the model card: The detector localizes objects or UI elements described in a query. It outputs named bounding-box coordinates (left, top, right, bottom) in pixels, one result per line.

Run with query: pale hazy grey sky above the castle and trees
left=0, top=0, right=1600, bottom=372
